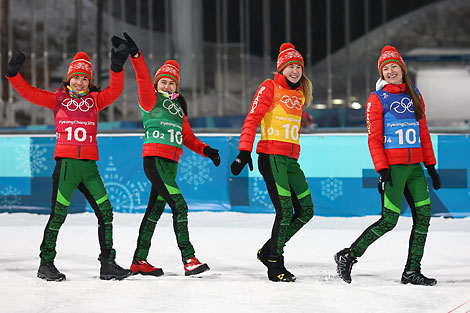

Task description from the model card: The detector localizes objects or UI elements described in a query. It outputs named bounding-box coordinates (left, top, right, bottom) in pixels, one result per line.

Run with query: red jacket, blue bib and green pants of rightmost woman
left=351, top=84, right=436, bottom=269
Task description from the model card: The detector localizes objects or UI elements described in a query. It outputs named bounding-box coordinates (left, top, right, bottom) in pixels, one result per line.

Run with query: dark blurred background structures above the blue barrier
left=0, top=0, right=470, bottom=131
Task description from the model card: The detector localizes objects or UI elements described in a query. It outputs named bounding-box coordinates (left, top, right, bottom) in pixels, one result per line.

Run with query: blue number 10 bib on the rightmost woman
left=374, top=90, right=421, bottom=149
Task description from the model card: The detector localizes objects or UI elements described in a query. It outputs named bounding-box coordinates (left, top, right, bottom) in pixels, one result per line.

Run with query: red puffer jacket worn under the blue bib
left=366, top=84, right=436, bottom=172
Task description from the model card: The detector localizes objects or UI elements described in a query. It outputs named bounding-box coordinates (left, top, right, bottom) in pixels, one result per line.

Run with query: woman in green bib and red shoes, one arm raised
left=113, top=33, right=220, bottom=276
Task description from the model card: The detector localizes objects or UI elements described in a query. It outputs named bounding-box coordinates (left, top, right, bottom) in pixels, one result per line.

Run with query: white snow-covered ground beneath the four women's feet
left=0, top=212, right=470, bottom=313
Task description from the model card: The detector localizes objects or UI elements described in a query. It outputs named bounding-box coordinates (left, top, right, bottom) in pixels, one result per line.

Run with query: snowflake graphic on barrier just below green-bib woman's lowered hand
left=177, top=154, right=212, bottom=191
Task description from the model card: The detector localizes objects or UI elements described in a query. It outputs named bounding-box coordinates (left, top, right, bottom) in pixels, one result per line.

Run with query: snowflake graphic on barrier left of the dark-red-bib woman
left=15, top=144, right=48, bottom=177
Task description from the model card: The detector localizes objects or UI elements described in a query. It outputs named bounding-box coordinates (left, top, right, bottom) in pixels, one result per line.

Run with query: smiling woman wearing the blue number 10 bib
left=335, top=46, right=441, bottom=286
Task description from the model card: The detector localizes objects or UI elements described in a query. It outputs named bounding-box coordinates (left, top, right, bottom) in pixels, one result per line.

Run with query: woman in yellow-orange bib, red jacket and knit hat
left=231, top=43, right=313, bottom=282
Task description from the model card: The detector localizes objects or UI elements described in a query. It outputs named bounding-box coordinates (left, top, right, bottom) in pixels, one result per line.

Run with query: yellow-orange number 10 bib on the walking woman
left=261, top=82, right=305, bottom=144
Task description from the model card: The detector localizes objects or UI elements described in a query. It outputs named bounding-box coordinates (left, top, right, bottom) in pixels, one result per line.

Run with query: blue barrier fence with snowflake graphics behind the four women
left=0, top=134, right=470, bottom=217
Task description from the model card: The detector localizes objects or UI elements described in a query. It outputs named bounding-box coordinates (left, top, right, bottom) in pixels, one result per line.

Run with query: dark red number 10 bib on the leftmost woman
left=54, top=90, right=98, bottom=146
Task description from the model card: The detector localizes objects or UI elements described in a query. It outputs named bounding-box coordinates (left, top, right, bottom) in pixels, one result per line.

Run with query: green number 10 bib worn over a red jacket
left=140, top=92, right=184, bottom=148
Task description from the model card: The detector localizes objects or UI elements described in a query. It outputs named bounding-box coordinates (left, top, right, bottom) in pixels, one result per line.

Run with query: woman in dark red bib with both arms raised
left=6, top=45, right=132, bottom=281
